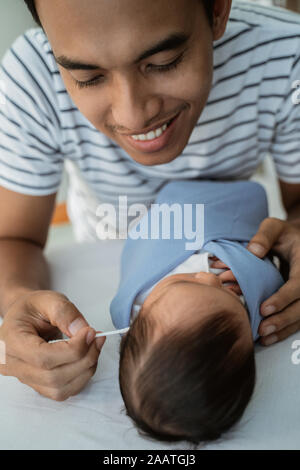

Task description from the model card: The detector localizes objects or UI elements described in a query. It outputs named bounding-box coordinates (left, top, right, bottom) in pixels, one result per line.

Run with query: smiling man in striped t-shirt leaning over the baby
left=0, top=0, right=300, bottom=400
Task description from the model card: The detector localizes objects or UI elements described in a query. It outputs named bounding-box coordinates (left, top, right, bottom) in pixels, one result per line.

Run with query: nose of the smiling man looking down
left=111, top=74, right=161, bottom=134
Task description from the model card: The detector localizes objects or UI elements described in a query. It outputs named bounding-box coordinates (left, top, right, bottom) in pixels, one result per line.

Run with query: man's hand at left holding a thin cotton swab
left=0, top=290, right=105, bottom=401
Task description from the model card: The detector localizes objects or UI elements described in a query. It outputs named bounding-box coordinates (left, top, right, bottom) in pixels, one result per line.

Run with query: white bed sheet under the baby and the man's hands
left=0, top=159, right=300, bottom=450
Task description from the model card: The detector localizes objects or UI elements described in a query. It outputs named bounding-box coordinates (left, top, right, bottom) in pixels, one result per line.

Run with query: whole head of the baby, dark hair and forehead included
left=119, top=272, right=255, bottom=445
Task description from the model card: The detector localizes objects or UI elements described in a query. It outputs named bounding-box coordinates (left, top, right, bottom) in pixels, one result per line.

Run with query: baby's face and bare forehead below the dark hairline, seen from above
left=143, top=272, right=252, bottom=341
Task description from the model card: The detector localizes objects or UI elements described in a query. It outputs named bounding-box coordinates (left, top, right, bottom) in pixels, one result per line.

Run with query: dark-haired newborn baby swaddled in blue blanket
left=111, top=181, right=283, bottom=445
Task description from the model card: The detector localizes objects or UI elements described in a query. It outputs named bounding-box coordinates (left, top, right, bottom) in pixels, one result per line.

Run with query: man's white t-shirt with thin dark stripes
left=0, top=0, right=300, bottom=240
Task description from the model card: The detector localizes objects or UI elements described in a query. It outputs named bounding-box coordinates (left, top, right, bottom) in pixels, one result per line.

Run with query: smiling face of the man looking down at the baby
left=36, top=0, right=231, bottom=165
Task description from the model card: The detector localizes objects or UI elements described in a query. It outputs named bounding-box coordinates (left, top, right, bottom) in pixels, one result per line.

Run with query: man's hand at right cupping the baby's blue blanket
left=248, top=217, right=300, bottom=346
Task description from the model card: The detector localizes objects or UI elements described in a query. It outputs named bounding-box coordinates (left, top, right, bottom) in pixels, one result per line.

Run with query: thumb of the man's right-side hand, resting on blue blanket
left=247, top=217, right=286, bottom=258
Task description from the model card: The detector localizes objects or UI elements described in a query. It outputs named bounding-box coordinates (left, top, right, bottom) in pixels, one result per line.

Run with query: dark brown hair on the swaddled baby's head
left=119, top=310, right=256, bottom=446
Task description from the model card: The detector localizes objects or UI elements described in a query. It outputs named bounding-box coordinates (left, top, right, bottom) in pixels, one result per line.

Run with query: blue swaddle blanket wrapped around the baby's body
left=110, top=180, right=284, bottom=341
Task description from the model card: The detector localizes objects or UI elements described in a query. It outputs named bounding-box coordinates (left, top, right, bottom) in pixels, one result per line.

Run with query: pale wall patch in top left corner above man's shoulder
left=0, top=0, right=35, bottom=59
